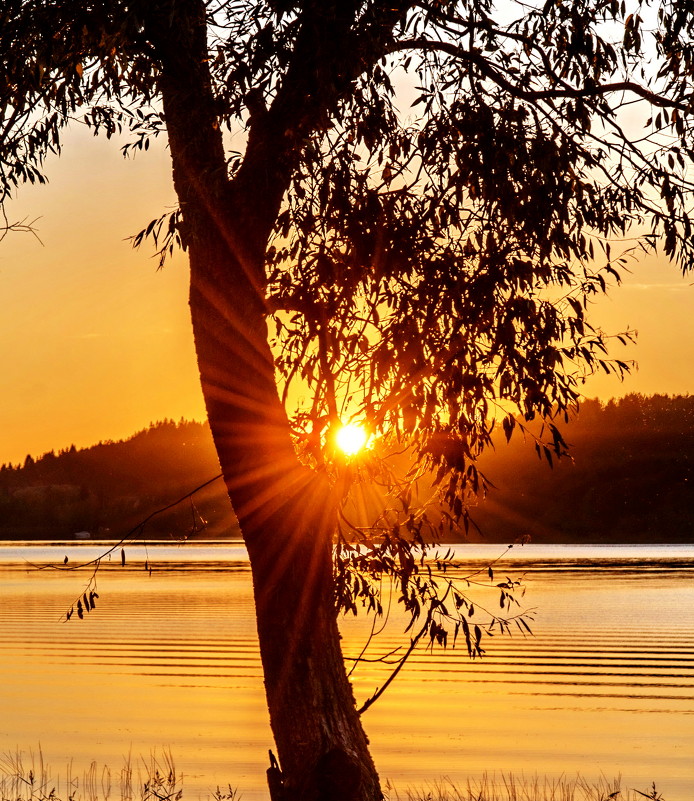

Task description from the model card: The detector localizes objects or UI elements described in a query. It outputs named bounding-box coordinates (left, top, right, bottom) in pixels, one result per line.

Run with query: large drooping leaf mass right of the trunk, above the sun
left=268, top=2, right=694, bottom=505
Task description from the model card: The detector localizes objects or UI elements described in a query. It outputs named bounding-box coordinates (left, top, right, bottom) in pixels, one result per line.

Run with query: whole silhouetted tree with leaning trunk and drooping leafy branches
left=0, top=0, right=694, bottom=801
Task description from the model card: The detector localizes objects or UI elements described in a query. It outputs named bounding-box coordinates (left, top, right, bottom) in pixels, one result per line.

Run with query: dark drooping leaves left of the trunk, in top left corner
left=0, top=0, right=169, bottom=198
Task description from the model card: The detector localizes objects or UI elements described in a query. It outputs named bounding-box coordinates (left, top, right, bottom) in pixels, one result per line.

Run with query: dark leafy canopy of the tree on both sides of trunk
left=8, top=0, right=693, bottom=494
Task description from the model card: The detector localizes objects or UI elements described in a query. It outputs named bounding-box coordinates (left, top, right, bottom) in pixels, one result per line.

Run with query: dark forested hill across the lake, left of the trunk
left=0, top=420, right=238, bottom=539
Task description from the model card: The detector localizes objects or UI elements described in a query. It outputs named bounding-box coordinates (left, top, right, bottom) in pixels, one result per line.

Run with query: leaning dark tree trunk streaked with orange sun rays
left=145, top=0, right=382, bottom=801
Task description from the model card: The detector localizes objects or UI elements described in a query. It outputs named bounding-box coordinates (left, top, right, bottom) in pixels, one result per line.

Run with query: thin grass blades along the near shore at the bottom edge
left=0, top=748, right=665, bottom=801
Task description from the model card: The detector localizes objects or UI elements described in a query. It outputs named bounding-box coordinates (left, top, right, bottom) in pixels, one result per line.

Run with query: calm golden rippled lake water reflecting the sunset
left=0, top=543, right=694, bottom=801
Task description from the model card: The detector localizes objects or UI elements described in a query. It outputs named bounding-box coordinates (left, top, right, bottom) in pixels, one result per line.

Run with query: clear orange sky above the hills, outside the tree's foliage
left=0, top=124, right=694, bottom=464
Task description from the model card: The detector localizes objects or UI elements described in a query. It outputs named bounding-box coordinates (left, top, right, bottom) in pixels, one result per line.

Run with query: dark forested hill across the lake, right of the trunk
left=472, top=394, right=694, bottom=543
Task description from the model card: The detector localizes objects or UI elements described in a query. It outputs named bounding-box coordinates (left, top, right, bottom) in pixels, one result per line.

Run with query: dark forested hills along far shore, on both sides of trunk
left=0, top=395, right=694, bottom=542
